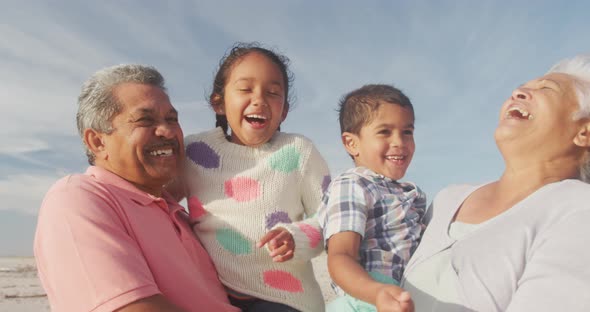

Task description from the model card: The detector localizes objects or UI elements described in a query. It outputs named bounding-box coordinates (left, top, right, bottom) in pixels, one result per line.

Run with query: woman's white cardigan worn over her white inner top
left=402, top=180, right=590, bottom=312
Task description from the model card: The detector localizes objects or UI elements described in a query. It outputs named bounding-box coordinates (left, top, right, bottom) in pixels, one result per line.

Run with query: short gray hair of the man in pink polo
left=76, top=64, right=166, bottom=165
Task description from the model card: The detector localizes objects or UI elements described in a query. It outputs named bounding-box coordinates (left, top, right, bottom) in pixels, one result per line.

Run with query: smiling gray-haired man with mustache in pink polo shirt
left=35, top=65, right=237, bottom=312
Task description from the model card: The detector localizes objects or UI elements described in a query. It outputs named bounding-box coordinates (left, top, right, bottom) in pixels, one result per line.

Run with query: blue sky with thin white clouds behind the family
left=0, top=0, right=590, bottom=256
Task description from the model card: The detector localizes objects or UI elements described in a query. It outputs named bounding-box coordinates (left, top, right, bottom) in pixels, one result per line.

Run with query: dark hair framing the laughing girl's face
left=209, top=42, right=293, bottom=135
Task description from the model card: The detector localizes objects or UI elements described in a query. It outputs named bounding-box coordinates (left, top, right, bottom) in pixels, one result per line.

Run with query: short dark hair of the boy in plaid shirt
left=338, top=84, right=414, bottom=135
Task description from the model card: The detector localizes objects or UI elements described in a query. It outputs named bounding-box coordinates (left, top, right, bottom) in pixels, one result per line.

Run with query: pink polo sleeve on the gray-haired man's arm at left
left=35, top=182, right=160, bottom=311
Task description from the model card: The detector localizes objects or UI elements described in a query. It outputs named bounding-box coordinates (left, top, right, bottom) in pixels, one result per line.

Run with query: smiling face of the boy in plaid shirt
left=342, top=102, right=416, bottom=180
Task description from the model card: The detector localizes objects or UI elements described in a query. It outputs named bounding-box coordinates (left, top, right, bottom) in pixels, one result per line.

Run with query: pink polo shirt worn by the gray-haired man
left=34, top=167, right=238, bottom=312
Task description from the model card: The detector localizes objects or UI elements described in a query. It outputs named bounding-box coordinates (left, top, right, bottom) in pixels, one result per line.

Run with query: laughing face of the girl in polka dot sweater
left=215, top=52, right=287, bottom=147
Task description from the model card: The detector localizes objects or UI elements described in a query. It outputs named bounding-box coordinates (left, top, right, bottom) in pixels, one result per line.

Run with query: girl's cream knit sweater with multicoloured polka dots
left=185, top=128, right=330, bottom=311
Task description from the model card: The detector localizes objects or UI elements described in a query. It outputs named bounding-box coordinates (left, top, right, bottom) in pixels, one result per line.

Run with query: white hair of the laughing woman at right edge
left=547, top=54, right=590, bottom=183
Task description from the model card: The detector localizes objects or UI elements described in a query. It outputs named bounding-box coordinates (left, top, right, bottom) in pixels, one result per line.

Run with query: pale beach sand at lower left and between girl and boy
left=0, top=254, right=334, bottom=312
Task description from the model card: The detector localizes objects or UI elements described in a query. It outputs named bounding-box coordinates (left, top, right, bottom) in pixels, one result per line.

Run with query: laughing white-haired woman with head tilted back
left=378, top=56, right=590, bottom=312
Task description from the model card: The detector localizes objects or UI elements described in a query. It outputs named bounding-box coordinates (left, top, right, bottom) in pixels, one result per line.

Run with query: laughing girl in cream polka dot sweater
left=185, top=44, right=330, bottom=311
